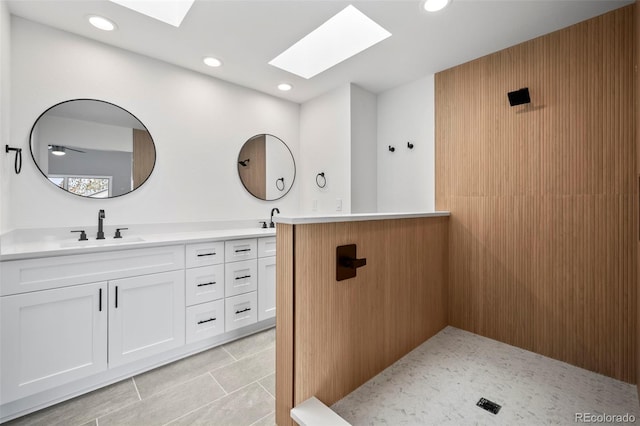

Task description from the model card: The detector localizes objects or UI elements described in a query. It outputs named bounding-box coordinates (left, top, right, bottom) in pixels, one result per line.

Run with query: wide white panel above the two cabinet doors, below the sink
left=0, top=245, right=184, bottom=296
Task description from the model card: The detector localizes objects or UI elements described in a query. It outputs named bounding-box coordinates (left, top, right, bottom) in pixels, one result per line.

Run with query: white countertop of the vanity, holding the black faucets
left=0, top=221, right=276, bottom=261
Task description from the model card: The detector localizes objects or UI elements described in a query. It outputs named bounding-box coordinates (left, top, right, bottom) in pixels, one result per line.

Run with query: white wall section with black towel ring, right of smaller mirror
left=296, top=84, right=351, bottom=214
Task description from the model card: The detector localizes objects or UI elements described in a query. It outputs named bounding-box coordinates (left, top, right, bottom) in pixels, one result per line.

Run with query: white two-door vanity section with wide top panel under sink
left=0, top=245, right=184, bottom=404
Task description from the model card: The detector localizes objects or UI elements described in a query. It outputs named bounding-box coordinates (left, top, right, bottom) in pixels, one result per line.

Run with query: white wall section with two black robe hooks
left=378, top=75, right=435, bottom=212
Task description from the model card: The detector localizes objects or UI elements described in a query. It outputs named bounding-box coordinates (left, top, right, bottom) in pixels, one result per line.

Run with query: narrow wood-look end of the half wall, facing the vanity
left=276, top=223, right=295, bottom=426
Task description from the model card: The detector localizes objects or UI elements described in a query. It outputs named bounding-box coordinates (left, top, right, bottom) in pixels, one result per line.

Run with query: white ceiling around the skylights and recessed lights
left=6, top=0, right=633, bottom=103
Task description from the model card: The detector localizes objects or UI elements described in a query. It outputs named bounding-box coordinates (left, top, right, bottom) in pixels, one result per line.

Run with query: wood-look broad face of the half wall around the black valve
left=288, top=217, right=448, bottom=405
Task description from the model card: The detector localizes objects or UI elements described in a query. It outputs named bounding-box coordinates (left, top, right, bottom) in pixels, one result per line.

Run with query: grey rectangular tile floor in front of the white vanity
left=6, top=328, right=275, bottom=426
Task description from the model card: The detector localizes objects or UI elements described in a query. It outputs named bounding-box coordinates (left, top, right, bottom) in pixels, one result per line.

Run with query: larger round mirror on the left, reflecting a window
left=31, top=99, right=156, bottom=198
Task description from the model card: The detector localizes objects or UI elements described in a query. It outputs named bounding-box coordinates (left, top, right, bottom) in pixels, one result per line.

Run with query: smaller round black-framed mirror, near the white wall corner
left=238, top=134, right=296, bottom=201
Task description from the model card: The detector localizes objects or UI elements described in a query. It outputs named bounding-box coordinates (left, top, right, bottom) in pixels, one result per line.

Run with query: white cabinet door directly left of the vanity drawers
left=109, top=271, right=185, bottom=367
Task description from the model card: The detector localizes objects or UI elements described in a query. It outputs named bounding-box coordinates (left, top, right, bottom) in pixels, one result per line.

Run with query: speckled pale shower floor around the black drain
left=331, top=327, right=640, bottom=426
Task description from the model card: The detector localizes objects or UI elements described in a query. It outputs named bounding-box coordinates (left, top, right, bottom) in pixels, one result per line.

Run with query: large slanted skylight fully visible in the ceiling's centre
left=269, top=5, right=391, bottom=79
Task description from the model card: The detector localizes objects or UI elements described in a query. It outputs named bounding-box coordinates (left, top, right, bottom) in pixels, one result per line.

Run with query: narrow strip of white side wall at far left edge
left=0, top=1, right=10, bottom=230
